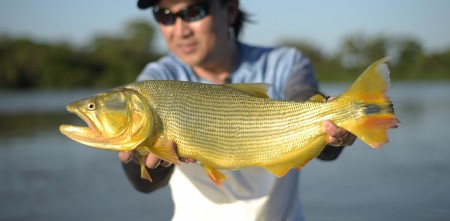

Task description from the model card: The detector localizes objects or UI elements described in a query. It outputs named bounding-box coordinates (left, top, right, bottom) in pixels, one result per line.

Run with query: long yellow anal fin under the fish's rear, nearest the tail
left=262, top=135, right=326, bottom=177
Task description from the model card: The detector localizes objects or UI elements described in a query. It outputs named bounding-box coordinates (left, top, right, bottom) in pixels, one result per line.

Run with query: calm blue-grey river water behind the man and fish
left=0, top=82, right=450, bottom=221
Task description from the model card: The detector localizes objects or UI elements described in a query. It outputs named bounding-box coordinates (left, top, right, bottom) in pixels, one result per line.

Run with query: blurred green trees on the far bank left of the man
left=0, top=21, right=160, bottom=88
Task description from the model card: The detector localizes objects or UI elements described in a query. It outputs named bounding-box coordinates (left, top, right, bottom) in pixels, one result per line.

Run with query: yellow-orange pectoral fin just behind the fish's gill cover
left=149, top=134, right=181, bottom=165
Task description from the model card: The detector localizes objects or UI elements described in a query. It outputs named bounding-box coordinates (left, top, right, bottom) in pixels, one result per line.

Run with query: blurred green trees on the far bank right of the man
left=282, top=33, right=450, bottom=82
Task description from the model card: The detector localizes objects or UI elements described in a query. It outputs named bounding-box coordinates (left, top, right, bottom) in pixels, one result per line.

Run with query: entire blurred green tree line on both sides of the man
left=0, top=21, right=450, bottom=89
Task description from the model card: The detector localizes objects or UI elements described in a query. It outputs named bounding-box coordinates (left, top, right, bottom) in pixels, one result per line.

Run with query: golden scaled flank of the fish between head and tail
left=126, top=81, right=338, bottom=169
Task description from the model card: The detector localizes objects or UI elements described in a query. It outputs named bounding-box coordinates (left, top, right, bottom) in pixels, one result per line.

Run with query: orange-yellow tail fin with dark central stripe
left=340, top=58, right=400, bottom=148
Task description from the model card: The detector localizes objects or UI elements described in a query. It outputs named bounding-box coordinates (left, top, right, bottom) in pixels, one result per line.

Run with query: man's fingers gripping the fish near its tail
left=322, top=121, right=356, bottom=147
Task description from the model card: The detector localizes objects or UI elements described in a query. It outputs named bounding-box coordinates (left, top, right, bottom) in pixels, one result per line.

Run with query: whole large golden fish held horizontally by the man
left=60, top=59, right=399, bottom=185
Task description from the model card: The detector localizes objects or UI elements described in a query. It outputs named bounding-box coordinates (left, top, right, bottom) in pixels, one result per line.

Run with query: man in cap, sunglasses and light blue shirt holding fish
left=119, top=0, right=356, bottom=220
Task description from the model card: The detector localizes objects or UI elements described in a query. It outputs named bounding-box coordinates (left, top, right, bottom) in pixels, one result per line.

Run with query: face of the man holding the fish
left=157, top=0, right=230, bottom=66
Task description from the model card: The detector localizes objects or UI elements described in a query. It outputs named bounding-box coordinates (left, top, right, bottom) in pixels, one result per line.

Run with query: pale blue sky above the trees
left=0, top=0, right=450, bottom=53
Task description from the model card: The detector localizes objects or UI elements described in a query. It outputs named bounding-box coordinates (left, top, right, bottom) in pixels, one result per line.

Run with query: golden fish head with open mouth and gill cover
left=60, top=88, right=154, bottom=151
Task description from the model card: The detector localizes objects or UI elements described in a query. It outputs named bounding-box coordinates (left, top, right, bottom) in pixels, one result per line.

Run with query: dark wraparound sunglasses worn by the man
left=153, top=2, right=209, bottom=25
